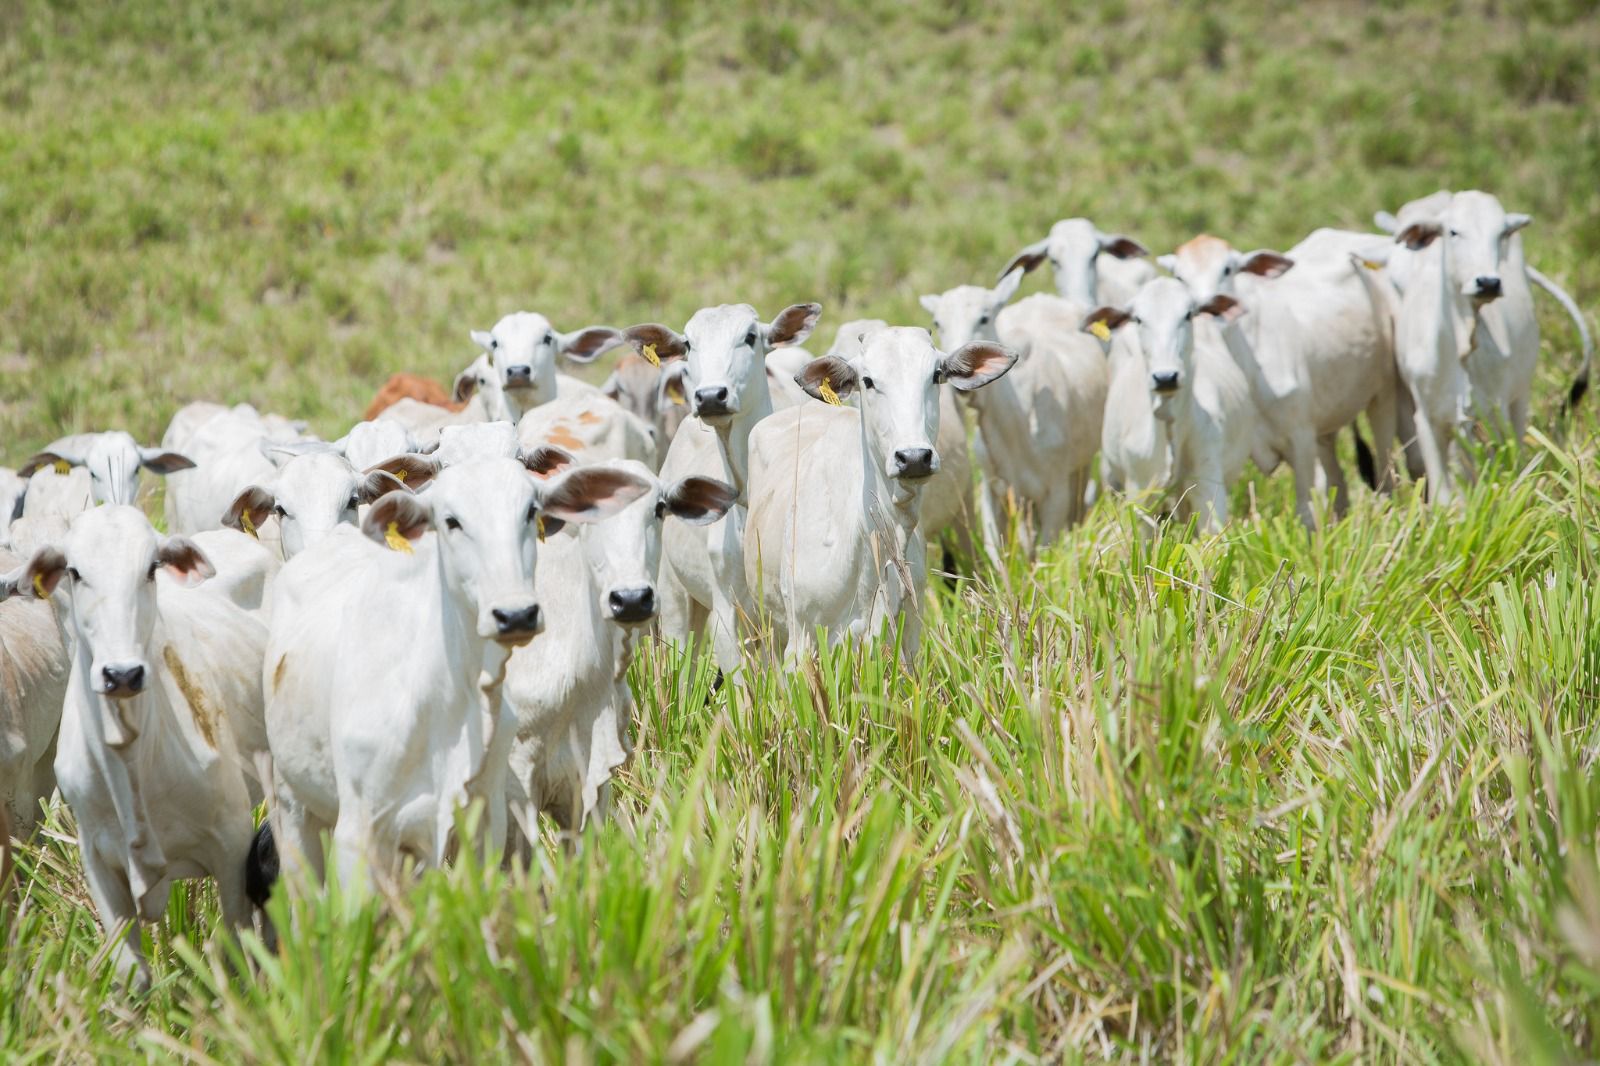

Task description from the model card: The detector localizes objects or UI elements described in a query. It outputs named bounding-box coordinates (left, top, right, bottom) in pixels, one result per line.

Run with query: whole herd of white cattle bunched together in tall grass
left=0, top=192, right=1592, bottom=986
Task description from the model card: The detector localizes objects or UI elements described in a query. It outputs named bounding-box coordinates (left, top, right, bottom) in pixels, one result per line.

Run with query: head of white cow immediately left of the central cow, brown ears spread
left=627, top=304, right=822, bottom=426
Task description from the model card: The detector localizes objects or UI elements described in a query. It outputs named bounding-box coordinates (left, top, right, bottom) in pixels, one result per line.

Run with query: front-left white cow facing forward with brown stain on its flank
left=12, top=504, right=266, bottom=989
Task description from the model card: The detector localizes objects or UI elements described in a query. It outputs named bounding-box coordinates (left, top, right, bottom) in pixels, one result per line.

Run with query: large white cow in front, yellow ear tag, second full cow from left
left=264, top=459, right=650, bottom=885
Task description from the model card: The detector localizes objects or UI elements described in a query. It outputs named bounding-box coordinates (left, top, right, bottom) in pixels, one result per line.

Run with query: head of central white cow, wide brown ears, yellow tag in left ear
left=795, top=327, right=1016, bottom=482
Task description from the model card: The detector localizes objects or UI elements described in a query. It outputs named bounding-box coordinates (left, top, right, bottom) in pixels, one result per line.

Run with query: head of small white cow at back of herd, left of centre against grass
left=456, top=311, right=622, bottom=423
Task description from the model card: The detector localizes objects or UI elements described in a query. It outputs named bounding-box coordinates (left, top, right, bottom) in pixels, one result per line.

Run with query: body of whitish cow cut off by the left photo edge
left=0, top=552, right=67, bottom=848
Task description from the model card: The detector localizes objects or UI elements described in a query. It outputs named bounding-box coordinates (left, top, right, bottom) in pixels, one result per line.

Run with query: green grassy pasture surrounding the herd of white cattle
left=0, top=0, right=1600, bottom=1064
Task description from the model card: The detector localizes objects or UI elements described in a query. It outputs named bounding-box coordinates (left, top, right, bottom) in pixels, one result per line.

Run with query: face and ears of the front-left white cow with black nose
left=24, top=504, right=216, bottom=701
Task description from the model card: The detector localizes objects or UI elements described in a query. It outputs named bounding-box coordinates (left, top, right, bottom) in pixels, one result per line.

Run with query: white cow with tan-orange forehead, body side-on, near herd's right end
left=1160, top=229, right=1397, bottom=528
